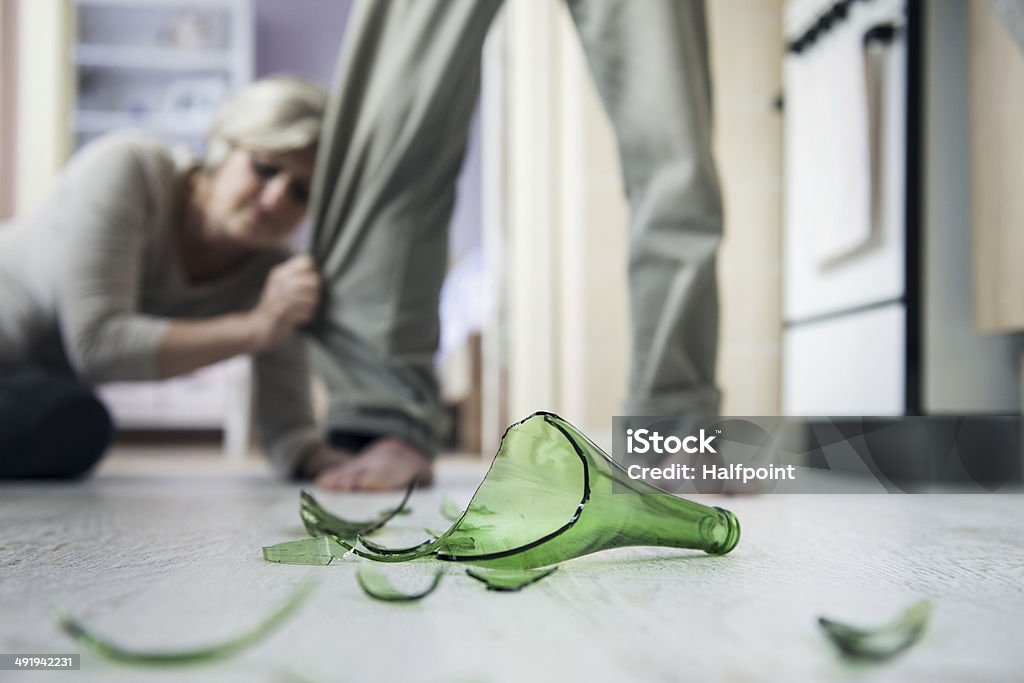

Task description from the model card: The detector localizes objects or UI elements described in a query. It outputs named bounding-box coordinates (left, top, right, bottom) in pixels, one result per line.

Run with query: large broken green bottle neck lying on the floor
left=355, top=413, right=739, bottom=569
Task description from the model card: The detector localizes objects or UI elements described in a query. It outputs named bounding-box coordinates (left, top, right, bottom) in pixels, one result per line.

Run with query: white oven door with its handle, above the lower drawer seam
left=783, top=0, right=907, bottom=323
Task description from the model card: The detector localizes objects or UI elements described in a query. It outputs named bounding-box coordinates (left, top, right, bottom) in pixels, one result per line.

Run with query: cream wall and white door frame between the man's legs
left=482, top=2, right=629, bottom=453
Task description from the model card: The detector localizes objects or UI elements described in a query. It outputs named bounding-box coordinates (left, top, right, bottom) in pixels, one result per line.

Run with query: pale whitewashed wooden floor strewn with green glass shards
left=0, top=453, right=1024, bottom=683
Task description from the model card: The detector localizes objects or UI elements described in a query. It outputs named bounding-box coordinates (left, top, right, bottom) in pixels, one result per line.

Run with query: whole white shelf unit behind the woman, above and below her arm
left=69, top=0, right=254, bottom=458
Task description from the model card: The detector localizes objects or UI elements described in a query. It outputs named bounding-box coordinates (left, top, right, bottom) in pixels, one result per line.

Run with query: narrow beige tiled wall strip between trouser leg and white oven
left=707, top=0, right=782, bottom=415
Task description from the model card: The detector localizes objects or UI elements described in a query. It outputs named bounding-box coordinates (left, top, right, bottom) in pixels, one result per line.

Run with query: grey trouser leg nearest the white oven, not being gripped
left=567, top=0, right=722, bottom=415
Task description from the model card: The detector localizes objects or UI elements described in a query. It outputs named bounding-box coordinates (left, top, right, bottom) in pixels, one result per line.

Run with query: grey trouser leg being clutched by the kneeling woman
left=311, top=0, right=500, bottom=487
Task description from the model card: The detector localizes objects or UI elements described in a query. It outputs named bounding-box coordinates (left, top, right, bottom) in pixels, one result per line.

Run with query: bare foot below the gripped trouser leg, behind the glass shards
left=315, top=437, right=433, bottom=490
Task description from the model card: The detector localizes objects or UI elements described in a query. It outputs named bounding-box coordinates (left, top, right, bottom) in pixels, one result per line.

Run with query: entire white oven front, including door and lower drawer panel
left=782, top=0, right=913, bottom=416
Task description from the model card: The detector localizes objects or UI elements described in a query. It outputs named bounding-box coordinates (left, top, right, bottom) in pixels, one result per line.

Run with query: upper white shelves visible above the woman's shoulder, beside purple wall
left=70, top=0, right=254, bottom=152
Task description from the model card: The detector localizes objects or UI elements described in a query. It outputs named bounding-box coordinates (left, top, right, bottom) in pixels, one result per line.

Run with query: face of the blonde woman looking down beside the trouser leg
left=199, top=146, right=316, bottom=249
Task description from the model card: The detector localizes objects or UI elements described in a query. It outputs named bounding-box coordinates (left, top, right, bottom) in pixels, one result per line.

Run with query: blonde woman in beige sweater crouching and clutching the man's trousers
left=0, top=77, right=430, bottom=488
